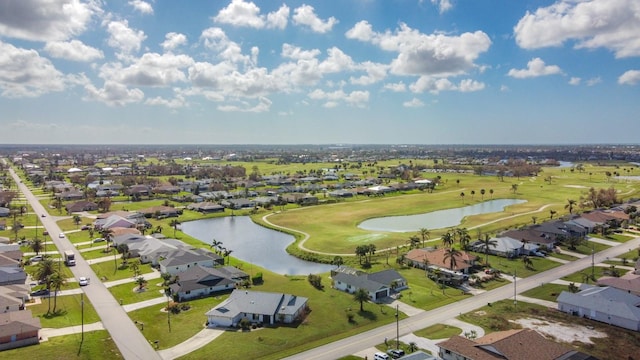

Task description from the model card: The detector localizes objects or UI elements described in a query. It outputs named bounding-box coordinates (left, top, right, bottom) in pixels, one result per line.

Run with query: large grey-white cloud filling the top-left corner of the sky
left=0, top=0, right=101, bottom=41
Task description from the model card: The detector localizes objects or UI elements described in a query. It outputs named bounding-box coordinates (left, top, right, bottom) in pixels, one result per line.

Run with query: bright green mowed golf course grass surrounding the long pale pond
left=262, top=167, right=640, bottom=255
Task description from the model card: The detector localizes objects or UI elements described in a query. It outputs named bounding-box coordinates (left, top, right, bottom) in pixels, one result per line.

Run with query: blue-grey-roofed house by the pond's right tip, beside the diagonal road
left=331, top=267, right=407, bottom=302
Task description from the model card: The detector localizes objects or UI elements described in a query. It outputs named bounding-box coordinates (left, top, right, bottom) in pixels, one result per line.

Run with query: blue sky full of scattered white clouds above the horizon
left=0, top=0, right=640, bottom=145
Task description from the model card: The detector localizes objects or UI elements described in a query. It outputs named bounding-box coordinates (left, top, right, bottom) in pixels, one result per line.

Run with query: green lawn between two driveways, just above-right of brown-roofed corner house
left=27, top=294, right=100, bottom=328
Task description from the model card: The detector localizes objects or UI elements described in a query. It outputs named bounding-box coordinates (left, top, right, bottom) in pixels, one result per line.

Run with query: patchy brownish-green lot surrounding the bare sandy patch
left=458, top=300, right=640, bottom=359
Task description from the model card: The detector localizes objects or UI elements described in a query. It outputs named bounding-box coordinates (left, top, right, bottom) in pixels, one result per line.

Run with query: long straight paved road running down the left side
left=9, top=168, right=160, bottom=360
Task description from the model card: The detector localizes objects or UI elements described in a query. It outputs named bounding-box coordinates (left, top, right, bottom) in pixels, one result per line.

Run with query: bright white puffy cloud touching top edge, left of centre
left=213, top=0, right=290, bottom=29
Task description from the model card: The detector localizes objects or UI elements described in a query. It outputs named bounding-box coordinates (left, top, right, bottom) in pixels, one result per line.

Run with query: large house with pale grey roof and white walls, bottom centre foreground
left=206, top=290, right=308, bottom=327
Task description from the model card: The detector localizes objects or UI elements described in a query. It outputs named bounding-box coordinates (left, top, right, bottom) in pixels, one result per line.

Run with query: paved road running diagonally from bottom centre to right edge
left=286, top=237, right=640, bottom=360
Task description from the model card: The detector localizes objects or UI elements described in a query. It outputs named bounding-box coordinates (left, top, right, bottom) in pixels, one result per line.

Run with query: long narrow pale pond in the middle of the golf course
left=358, top=199, right=526, bottom=232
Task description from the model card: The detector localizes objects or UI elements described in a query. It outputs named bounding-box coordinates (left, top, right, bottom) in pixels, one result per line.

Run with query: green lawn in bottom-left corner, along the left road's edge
left=2, top=330, right=122, bottom=360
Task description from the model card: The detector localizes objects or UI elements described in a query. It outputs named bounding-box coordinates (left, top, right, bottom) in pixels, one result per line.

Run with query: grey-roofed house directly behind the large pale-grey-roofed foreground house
left=169, top=265, right=249, bottom=301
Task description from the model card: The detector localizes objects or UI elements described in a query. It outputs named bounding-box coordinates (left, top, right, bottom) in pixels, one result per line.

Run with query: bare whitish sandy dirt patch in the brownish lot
left=511, top=318, right=607, bottom=344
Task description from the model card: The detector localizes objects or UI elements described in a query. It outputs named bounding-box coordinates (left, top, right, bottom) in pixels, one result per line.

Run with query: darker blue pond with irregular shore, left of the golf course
left=181, top=216, right=334, bottom=275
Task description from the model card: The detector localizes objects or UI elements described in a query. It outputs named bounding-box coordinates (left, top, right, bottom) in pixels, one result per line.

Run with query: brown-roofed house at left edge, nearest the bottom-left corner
left=0, top=310, right=42, bottom=351
